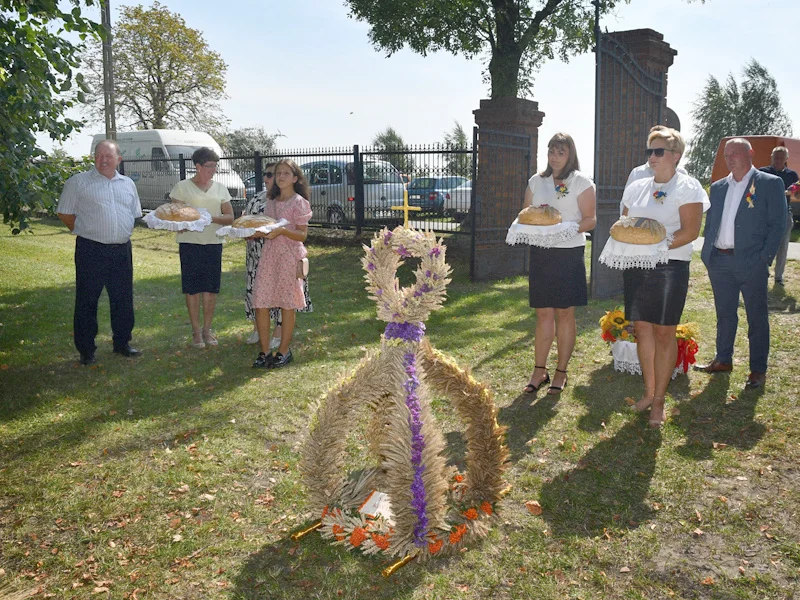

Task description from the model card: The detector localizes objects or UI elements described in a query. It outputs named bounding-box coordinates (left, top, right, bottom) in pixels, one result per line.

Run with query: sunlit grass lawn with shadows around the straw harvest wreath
left=0, top=220, right=800, bottom=600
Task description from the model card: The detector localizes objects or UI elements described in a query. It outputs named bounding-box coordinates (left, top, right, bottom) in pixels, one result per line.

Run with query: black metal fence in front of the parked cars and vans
left=120, top=145, right=477, bottom=233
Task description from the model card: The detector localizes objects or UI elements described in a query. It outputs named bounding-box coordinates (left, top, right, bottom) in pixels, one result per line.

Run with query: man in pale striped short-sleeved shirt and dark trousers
left=58, top=140, right=142, bottom=365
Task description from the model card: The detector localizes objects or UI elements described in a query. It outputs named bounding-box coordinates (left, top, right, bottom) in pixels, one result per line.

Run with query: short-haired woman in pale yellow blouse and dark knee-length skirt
left=169, top=148, right=233, bottom=348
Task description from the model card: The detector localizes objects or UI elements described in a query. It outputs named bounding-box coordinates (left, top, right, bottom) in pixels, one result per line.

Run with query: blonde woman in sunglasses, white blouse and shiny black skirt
left=622, top=128, right=710, bottom=428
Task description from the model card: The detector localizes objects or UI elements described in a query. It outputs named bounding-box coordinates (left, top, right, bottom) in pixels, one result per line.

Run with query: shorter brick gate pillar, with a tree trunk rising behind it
left=470, top=98, right=544, bottom=281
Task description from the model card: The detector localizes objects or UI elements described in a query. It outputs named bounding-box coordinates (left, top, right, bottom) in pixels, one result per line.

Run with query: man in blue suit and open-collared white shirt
left=695, top=138, right=786, bottom=389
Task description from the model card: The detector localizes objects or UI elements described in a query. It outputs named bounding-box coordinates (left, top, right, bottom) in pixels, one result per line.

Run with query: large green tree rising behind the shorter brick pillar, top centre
left=345, top=0, right=704, bottom=98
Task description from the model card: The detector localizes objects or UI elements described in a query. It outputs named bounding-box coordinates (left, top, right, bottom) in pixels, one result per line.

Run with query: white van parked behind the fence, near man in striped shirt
left=91, top=129, right=245, bottom=214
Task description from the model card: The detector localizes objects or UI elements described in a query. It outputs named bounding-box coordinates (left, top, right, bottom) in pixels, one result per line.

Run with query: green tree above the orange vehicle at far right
left=686, top=59, right=792, bottom=185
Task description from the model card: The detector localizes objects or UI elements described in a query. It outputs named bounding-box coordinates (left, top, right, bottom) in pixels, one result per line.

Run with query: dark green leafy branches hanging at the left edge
left=0, top=0, right=101, bottom=233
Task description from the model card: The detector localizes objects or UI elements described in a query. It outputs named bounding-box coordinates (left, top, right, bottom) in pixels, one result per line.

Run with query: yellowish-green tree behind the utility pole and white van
left=84, top=2, right=228, bottom=134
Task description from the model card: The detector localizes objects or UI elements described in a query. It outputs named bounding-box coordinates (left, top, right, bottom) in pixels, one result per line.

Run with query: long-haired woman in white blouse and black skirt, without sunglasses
left=523, top=133, right=597, bottom=394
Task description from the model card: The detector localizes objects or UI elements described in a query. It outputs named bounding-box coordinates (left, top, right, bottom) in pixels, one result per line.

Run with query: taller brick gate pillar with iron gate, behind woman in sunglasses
left=590, top=29, right=677, bottom=298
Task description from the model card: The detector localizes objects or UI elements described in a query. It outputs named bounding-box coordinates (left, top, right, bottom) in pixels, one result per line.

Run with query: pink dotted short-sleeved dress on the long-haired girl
left=253, top=194, right=311, bottom=310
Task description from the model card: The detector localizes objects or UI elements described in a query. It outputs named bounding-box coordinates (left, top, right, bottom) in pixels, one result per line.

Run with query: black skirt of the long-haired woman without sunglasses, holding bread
left=528, top=246, right=589, bottom=308
